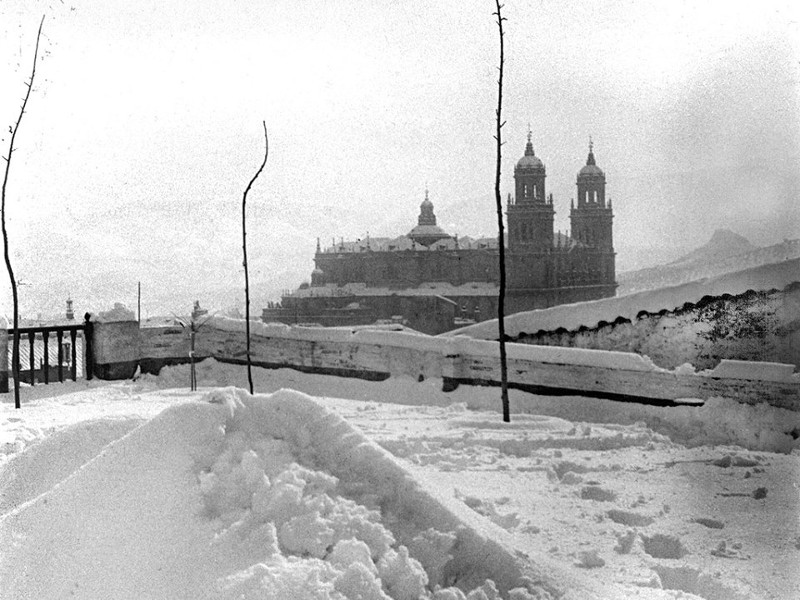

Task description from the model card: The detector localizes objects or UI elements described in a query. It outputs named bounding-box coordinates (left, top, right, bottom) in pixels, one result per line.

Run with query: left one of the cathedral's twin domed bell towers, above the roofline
left=507, top=130, right=555, bottom=252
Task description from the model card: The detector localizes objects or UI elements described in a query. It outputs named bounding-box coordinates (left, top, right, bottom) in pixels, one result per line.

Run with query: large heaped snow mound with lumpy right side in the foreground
left=0, top=388, right=586, bottom=600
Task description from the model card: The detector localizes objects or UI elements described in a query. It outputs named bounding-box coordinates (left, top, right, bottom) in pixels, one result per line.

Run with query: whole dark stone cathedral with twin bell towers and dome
left=262, top=132, right=617, bottom=334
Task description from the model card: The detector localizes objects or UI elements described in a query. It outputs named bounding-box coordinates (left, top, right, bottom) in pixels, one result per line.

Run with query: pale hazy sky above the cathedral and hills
left=0, top=0, right=800, bottom=313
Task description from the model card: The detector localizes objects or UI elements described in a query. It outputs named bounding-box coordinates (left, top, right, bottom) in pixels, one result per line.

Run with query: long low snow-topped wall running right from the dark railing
left=86, top=319, right=800, bottom=410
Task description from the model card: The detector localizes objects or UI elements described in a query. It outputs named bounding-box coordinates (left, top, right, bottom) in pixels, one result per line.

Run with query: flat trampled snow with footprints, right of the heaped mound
left=326, top=398, right=800, bottom=600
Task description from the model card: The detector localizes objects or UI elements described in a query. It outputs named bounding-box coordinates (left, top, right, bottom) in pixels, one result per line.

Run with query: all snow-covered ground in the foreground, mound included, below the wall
left=0, top=360, right=800, bottom=600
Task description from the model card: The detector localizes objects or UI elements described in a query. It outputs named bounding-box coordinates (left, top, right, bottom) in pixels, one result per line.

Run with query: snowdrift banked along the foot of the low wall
left=143, top=359, right=800, bottom=453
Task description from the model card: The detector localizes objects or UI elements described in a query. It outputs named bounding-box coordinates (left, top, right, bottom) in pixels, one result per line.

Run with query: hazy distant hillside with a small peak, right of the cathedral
left=617, top=229, right=800, bottom=296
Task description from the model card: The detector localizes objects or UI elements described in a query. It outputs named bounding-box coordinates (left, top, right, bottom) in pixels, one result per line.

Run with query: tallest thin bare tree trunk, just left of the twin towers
left=494, top=0, right=511, bottom=423
